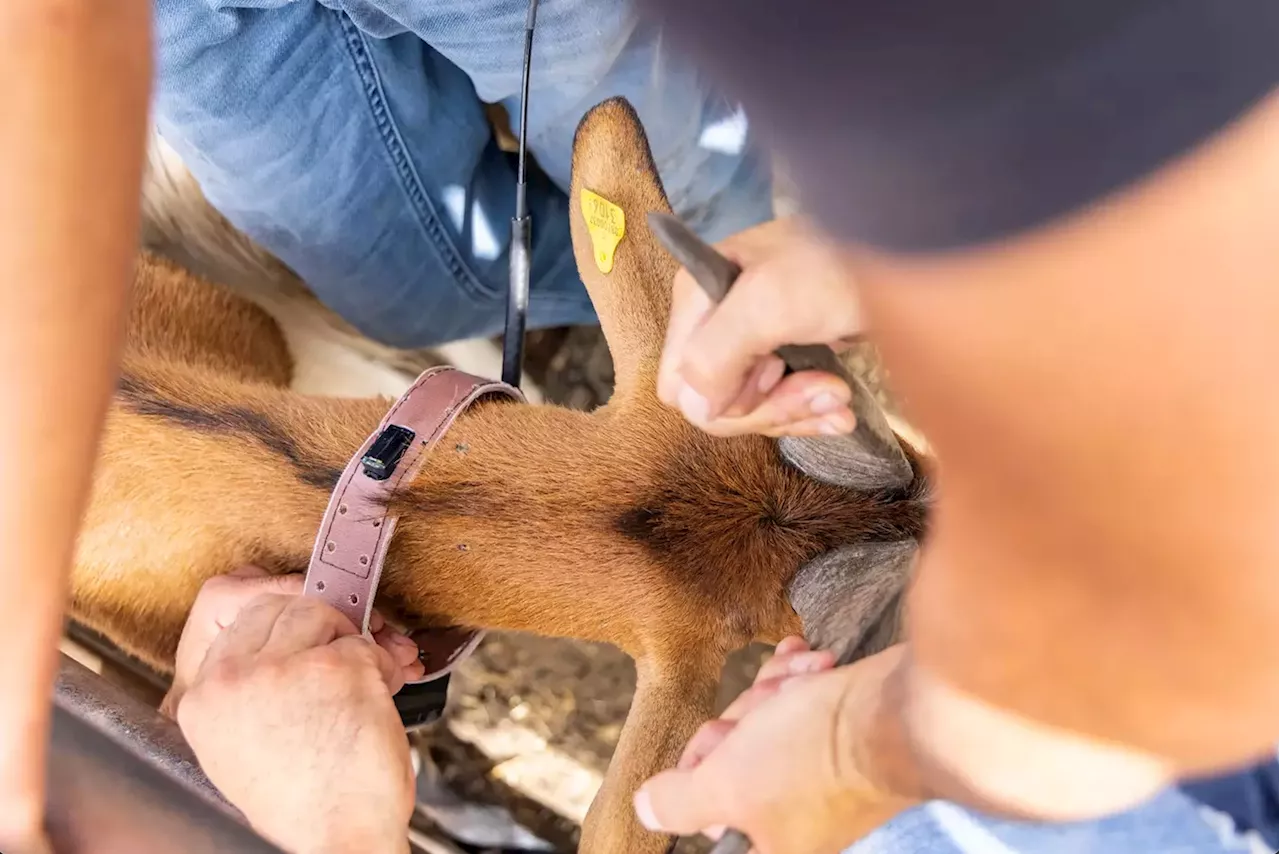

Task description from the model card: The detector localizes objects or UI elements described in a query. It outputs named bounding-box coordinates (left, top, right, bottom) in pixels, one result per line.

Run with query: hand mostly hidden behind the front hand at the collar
left=160, top=566, right=426, bottom=717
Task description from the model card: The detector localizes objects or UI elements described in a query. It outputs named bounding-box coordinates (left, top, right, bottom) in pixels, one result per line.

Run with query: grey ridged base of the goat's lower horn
left=787, top=540, right=918, bottom=662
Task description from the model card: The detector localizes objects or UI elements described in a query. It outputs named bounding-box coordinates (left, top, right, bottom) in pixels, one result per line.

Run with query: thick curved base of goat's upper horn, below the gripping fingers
left=778, top=363, right=915, bottom=490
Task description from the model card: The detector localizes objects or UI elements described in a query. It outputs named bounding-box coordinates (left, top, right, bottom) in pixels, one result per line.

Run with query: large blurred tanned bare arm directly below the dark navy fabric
left=858, top=99, right=1280, bottom=773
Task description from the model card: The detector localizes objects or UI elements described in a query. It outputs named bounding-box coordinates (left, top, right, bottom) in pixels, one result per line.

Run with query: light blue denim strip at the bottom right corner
left=845, top=763, right=1280, bottom=854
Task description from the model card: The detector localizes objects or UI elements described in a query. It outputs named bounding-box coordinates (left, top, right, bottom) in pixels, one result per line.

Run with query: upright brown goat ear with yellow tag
left=570, top=97, right=677, bottom=394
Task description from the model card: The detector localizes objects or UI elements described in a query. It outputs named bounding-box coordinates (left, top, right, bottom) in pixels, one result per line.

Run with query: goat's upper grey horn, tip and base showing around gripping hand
left=649, top=211, right=914, bottom=489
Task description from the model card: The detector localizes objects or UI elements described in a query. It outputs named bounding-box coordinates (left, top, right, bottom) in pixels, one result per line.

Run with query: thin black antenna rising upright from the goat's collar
left=502, top=0, right=538, bottom=388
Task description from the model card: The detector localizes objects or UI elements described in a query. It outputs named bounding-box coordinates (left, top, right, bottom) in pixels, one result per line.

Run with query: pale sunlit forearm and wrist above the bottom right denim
left=835, top=644, right=1171, bottom=819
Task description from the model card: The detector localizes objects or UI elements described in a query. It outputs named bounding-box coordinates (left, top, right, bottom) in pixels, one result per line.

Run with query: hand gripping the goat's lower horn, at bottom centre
left=636, top=638, right=910, bottom=854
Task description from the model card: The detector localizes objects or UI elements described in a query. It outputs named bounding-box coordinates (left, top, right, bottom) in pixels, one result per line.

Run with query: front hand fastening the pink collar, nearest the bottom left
left=177, top=594, right=413, bottom=854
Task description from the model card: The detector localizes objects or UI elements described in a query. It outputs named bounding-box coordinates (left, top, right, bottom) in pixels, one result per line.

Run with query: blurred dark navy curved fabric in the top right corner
left=643, top=0, right=1280, bottom=251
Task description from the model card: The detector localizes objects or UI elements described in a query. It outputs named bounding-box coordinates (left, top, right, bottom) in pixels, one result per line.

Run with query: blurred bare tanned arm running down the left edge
left=0, top=0, right=151, bottom=851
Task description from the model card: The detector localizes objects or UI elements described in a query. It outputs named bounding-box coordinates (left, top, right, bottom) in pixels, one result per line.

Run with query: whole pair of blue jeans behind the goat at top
left=154, top=0, right=772, bottom=347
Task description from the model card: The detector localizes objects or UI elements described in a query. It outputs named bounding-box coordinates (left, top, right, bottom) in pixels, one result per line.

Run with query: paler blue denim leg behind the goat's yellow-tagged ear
left=340, top=0, right=773, bottom=239
